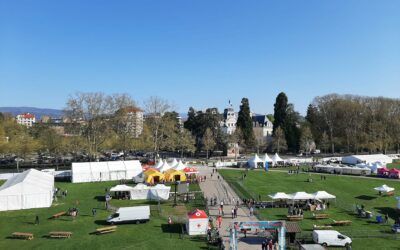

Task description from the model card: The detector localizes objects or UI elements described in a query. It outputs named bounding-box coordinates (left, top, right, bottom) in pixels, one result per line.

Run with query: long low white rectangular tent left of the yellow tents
left=71, top=161, right=143, bottom=183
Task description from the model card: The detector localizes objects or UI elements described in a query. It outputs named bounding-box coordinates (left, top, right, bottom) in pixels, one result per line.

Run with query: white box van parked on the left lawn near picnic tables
left=107, top=206, right=150, bottom=224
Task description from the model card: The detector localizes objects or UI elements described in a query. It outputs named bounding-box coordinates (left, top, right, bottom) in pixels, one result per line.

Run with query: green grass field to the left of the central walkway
left=0, top=182, right=212, bottom=249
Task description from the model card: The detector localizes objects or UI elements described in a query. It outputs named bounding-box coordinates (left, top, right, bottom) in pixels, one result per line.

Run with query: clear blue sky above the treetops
left=0, top=0, right=400, bottom=113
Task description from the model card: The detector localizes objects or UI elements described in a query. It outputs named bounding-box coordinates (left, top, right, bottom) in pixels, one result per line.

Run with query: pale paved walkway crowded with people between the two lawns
left=199, top=167, right=261, bottom=249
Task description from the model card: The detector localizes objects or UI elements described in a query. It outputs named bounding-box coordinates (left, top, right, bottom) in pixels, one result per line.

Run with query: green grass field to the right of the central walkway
left=219, top=170, right=400, bottom=249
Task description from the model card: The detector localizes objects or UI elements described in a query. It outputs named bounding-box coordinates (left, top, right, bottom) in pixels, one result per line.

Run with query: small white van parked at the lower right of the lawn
left=313, top=230, right=351, bottom=247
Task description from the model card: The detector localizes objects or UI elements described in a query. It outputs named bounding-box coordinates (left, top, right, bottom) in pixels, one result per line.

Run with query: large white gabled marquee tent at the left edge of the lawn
left=0, top=169, right=54, bottom=211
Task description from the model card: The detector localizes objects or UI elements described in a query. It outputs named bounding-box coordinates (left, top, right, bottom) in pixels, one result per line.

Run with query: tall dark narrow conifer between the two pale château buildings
left=236, top=98, right=255, bottom=147
